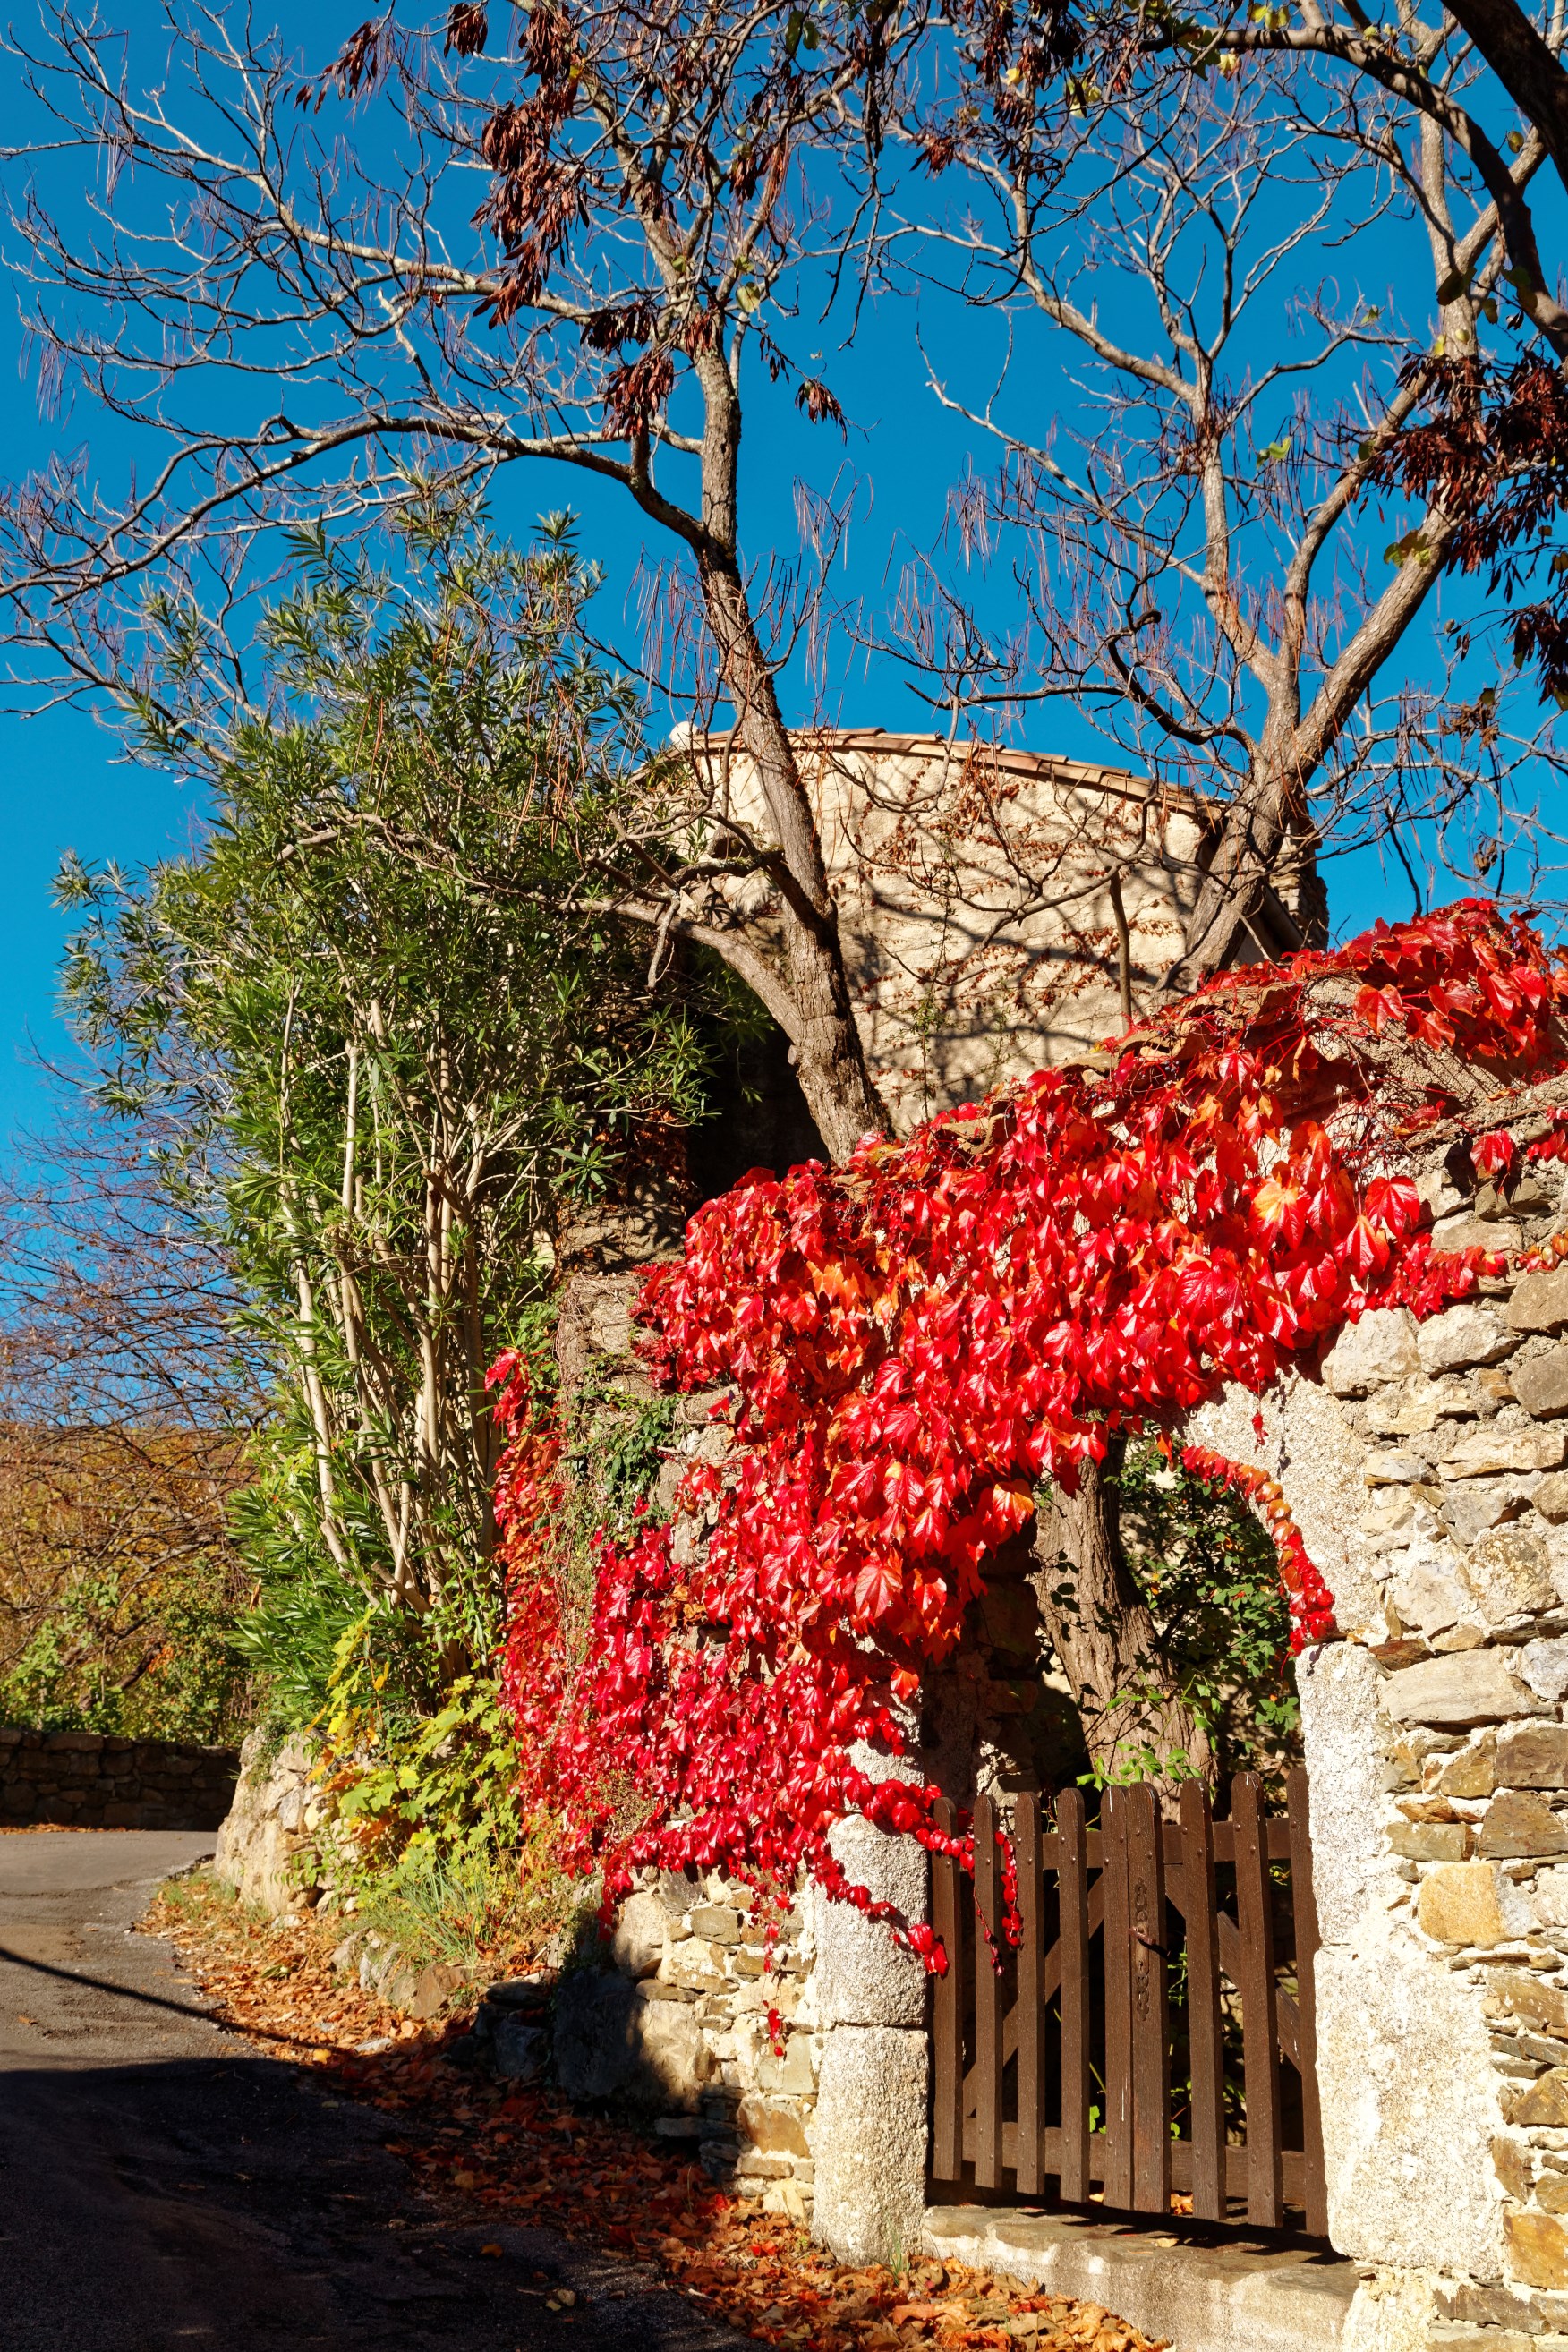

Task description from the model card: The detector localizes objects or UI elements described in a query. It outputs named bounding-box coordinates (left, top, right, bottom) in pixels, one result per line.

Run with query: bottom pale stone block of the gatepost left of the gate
left=811, top=2025, right=926, bottom=2270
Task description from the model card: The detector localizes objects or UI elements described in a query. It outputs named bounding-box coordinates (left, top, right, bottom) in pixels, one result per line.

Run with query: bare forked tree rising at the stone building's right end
left=888, top=38, right=1556, bottom=973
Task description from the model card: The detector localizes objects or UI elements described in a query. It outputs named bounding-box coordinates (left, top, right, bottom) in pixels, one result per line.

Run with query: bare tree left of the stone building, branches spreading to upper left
left=0, top=0, right=982, bottom=1157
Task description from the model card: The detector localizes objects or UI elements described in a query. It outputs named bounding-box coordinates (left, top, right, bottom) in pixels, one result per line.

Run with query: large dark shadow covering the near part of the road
left=0, top=2050, right=743, bottom=2352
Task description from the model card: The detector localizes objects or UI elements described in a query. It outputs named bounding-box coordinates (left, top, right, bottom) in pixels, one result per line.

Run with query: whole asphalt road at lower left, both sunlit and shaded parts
left=0, top=1832, right=746, bottom=2352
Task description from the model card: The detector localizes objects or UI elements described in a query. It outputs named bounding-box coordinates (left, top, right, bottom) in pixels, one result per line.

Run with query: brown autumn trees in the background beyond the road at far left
left=0, top=1087, right=266, bottom=1741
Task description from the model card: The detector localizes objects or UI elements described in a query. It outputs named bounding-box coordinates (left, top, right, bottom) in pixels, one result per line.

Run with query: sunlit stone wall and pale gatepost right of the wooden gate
left=1189, top=1185, right=1568, bottom=2352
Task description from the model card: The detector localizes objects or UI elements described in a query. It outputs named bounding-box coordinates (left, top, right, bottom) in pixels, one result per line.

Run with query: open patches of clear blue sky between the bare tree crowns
left=0, top=0, right=1542, bottom=1141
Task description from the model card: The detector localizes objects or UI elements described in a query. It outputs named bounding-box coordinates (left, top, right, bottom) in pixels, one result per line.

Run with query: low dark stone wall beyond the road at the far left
left=0, top=1731, right=240, bottom=1830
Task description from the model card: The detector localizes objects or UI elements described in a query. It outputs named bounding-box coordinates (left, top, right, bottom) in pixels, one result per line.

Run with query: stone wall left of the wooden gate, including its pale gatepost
left=555, top=1270, right=926, bottom=2263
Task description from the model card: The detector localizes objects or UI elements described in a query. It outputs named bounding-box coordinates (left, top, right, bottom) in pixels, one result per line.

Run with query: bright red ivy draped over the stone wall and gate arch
left=499, top=901, right=1568, bottom=1969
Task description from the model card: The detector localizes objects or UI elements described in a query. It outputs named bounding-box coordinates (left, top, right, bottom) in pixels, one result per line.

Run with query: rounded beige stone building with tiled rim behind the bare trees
left=689, top=727, right=1325, bottom=1134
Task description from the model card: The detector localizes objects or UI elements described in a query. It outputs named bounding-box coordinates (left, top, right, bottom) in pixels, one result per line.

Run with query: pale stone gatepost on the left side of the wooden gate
left=806, top=1750, right=929, bottom=2267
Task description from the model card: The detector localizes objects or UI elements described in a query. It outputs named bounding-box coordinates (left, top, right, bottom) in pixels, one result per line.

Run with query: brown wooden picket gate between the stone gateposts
left=931, top=1771, right=1328, bottom=2237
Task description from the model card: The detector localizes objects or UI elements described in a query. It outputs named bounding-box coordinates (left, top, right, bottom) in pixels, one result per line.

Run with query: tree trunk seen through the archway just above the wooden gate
left=1035, top=1449, right=1213, bottom=1785
